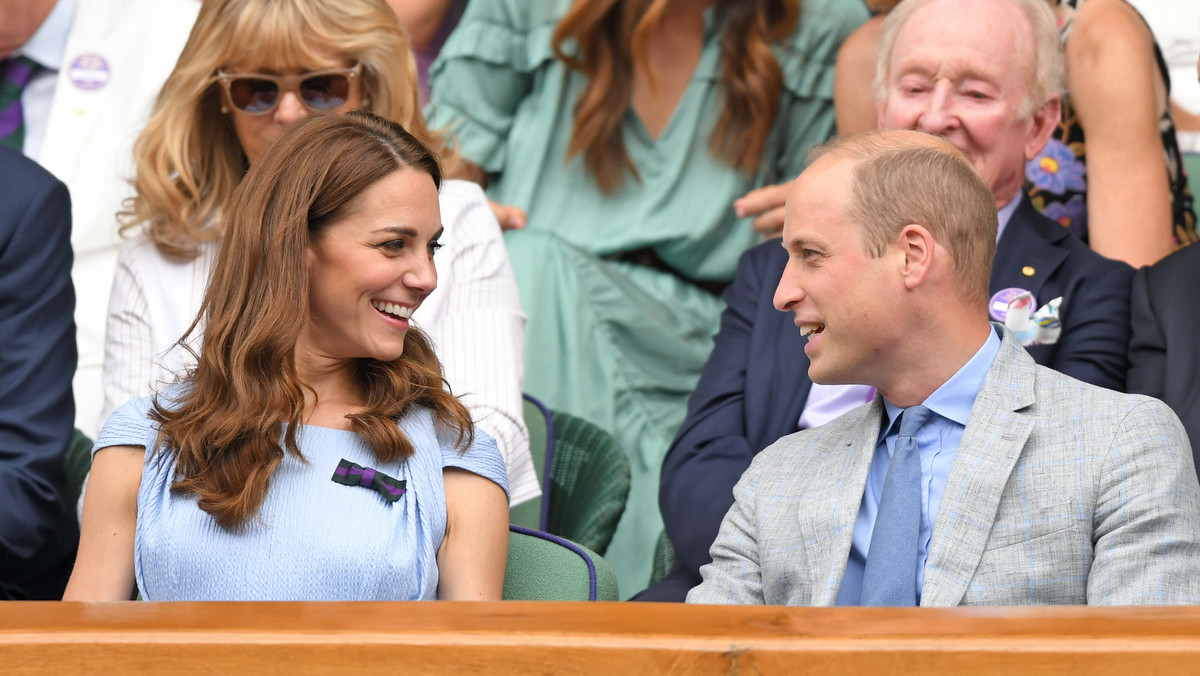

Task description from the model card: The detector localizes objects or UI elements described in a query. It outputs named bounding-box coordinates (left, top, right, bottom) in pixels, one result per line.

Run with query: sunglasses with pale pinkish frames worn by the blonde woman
left=217, top=64, right=362, bottom=115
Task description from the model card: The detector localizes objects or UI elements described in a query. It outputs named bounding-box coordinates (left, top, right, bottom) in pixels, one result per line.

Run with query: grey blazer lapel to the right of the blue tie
left=920, top=330, right=1037, bottom=606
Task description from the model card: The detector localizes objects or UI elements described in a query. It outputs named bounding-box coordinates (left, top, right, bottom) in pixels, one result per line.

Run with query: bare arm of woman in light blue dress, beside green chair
left=436, top=467, right=509, bottom=600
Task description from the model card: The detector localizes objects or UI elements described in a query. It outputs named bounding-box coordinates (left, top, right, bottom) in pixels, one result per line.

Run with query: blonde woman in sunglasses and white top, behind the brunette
left=102, top=0, right=539, bottom=503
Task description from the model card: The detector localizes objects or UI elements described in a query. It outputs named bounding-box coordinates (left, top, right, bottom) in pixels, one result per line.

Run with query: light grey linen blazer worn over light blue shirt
left=688, top=331, right=1200, bottom=606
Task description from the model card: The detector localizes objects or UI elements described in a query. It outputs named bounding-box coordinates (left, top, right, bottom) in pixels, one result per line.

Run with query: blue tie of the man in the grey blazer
left=862, top=406, right=932, bottom=605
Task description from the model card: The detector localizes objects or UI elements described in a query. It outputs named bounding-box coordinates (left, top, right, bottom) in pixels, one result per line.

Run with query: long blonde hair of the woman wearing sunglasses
left=118, top=0, right=462, bottom=258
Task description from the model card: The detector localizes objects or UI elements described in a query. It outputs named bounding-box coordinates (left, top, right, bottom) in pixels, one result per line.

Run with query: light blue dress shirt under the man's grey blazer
left=838, top=330, right=1000, bottom=605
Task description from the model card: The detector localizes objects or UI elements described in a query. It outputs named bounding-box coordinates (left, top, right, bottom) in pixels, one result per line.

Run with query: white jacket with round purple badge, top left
left=20, top=0, right=200, bottom=437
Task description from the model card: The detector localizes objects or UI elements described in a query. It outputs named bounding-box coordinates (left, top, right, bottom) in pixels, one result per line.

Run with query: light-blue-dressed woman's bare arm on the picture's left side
left=62, top=445, right=145, bottom=600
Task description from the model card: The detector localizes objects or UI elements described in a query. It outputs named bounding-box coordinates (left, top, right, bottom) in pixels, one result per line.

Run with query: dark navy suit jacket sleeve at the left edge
left=0, top=148, right=79, bottom=598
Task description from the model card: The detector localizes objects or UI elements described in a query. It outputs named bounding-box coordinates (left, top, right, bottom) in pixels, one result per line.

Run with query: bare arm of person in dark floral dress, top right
left=1067, top=0, right=1174, bottom=268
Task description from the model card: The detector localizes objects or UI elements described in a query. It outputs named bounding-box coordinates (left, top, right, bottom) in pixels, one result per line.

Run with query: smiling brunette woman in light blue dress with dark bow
left=65, top=113, right=508, bottom=600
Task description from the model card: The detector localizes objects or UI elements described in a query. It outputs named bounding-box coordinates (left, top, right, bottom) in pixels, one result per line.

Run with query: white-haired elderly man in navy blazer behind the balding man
left=640, top=0, right=1133, bottom=600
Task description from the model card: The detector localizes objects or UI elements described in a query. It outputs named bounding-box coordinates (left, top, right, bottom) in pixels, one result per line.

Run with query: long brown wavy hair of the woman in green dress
left=553, top=0, right=800, bottom=193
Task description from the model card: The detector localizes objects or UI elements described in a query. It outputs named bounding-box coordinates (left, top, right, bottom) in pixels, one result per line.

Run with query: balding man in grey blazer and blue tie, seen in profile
left=688, top=131, right=1200, bottom=606
